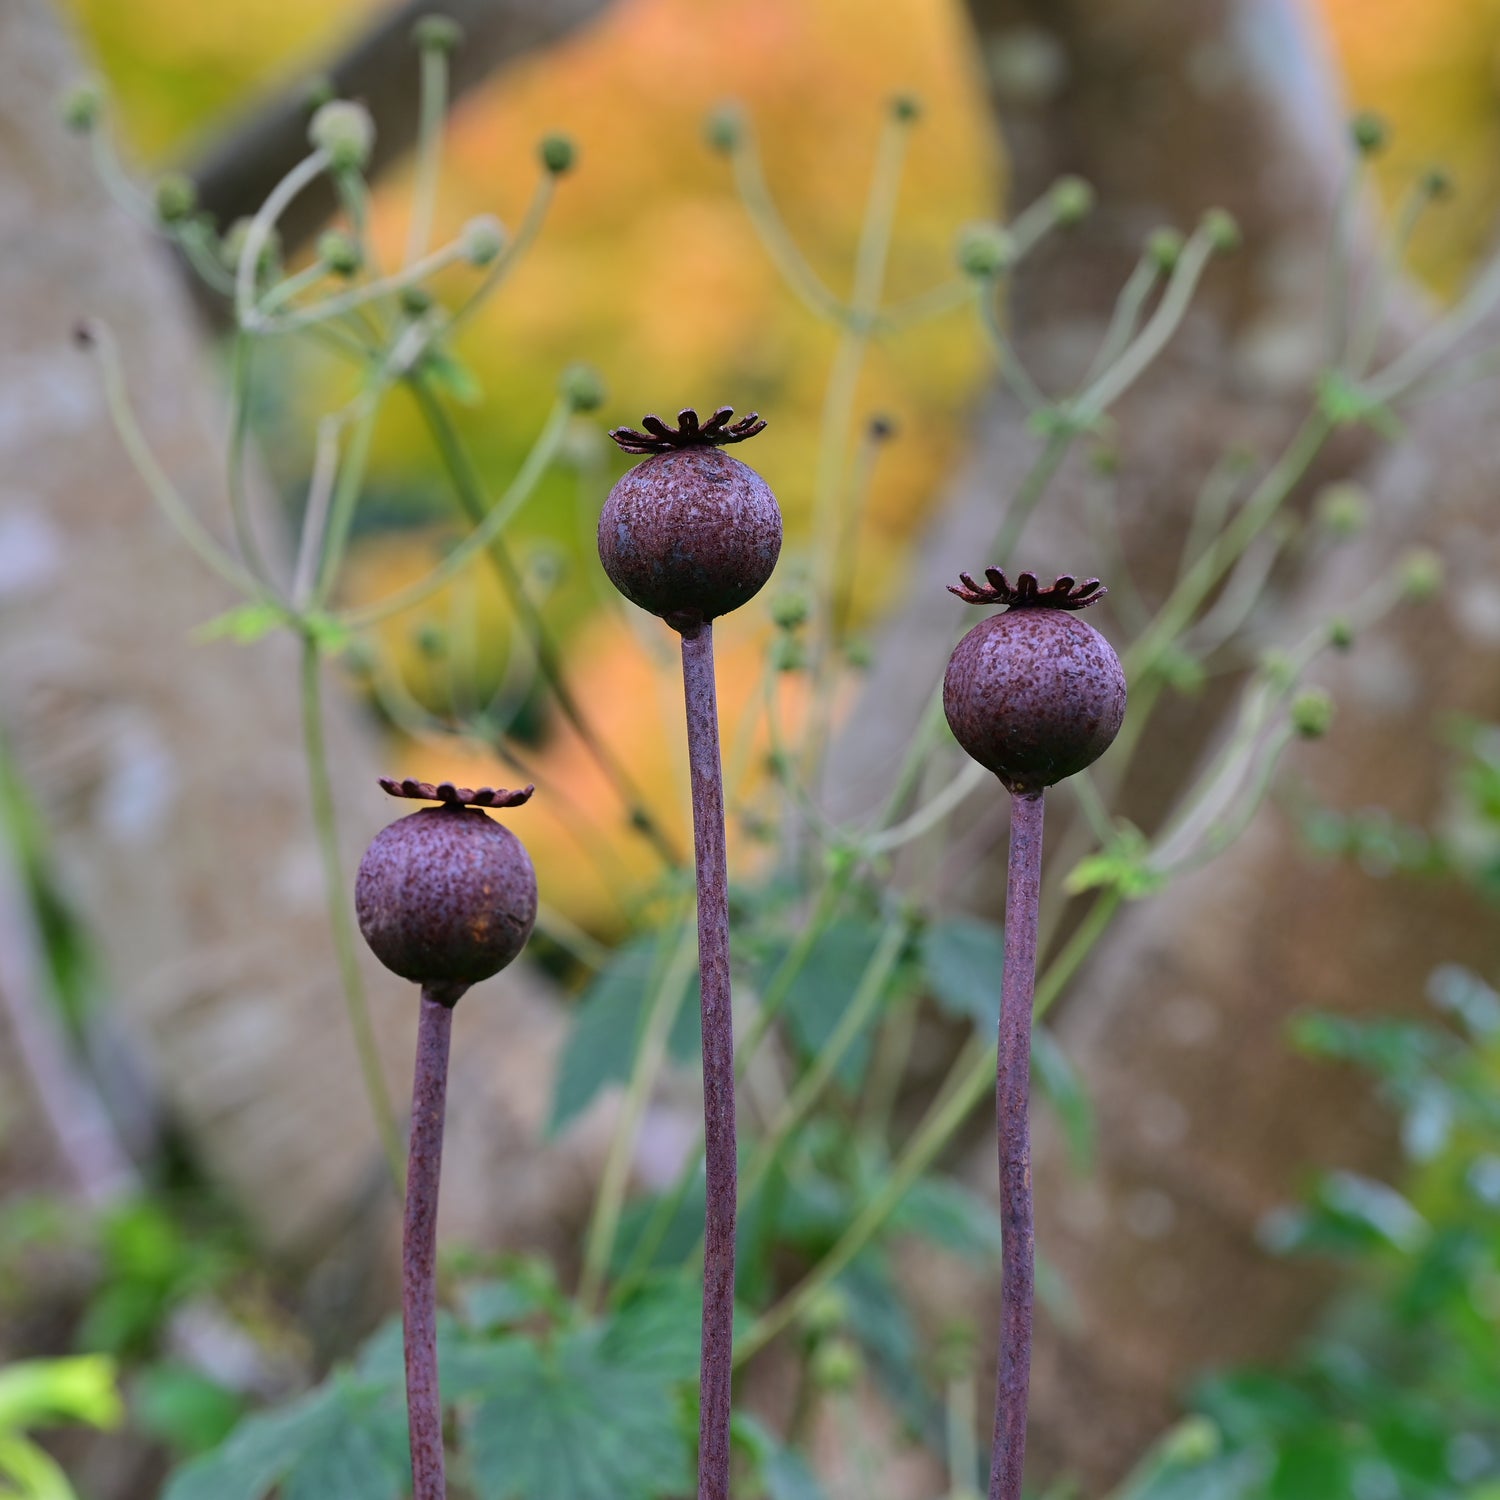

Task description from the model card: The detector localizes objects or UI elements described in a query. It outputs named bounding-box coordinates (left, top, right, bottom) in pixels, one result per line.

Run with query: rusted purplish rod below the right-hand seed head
left=990, top=791, right=1046, bottom=1500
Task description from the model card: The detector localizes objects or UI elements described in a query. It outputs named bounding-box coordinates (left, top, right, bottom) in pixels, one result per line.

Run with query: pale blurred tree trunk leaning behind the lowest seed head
left=0, top=0, right=609, bottom=1313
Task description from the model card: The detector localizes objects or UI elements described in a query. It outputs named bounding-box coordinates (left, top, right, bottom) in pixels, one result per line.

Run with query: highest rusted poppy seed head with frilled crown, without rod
left=599, top=407, right=782, bottom=635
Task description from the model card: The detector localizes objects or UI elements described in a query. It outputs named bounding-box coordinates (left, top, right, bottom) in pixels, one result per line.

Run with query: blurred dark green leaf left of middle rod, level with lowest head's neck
left=548, top=930, right=701, bottom=1136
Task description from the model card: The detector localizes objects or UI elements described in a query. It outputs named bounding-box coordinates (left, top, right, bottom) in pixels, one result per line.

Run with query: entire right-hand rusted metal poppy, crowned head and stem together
left=942, top=567, right=1125, bottom=1500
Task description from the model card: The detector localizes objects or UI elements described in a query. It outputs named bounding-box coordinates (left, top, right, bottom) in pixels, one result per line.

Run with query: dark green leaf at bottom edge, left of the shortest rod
left=162, top=1376, right=411, bottom=1500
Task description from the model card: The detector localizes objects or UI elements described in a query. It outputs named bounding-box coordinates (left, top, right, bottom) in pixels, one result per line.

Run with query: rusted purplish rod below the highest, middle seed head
left=683, top=624, right=738, bottom=1500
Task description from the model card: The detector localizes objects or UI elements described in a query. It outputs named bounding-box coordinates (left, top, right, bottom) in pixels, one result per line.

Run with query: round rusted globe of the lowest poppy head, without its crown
left=354, top=803, right=537, bottom=986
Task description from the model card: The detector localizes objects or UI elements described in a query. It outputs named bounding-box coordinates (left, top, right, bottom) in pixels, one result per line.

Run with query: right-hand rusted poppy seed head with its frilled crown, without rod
left=942, top=567, right=1125, bottom=795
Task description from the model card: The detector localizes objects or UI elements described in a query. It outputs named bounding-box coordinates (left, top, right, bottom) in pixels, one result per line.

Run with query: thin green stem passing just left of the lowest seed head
left=302, top=636, right=405, bottom=1197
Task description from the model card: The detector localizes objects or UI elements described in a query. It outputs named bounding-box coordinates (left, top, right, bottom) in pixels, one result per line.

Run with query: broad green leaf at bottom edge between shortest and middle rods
left=464, top=1329, right=692, bottom=1500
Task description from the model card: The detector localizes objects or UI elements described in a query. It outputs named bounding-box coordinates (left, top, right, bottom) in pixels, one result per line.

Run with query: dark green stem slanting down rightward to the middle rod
left=408, top=369, right=683, bottom=869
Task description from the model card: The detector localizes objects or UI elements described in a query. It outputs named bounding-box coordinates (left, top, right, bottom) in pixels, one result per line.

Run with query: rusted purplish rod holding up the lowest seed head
left=401, top=989, right=456, bottom=1500
